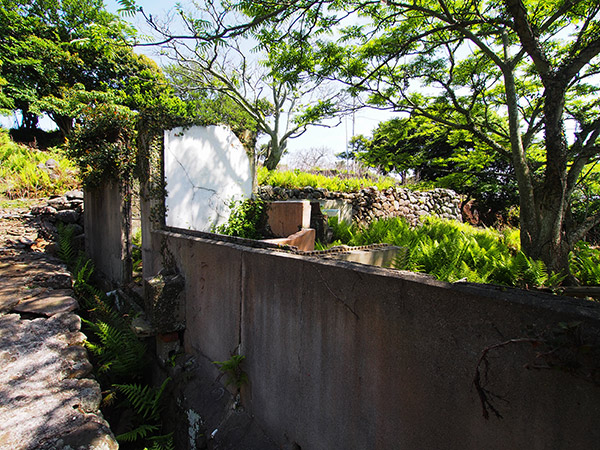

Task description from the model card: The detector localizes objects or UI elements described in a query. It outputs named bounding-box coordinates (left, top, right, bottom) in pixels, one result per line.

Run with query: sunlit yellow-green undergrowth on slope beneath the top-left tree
left=0, top=128, right=79, bottom=199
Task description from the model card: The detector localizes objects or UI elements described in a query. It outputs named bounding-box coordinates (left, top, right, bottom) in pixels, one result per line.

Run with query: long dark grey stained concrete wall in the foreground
left=151, top=231, right=600, bottom=450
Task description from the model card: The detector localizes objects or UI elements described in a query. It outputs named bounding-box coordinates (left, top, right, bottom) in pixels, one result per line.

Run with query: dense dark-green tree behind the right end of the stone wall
left=355, top=116, right=519, bottom=221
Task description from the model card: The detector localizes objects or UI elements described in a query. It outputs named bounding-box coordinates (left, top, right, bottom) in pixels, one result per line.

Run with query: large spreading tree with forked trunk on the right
left=221, top=0, right=600, bottom=280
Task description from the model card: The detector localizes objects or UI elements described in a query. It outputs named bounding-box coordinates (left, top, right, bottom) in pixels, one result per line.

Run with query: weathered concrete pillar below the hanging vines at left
left=83, top=183, right=132, bottom=284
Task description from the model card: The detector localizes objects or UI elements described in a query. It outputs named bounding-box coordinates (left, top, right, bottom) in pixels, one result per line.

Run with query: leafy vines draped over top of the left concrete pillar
left=68, top=104, right=136, bottom=188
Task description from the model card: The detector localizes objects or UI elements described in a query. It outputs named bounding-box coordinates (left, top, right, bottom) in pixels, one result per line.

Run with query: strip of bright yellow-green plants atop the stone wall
left=257, top=167, right=397, bottom=192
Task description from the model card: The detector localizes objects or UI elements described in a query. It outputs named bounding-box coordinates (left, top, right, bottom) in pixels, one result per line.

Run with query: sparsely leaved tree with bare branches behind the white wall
left=131, top=1, right=342, bottom=170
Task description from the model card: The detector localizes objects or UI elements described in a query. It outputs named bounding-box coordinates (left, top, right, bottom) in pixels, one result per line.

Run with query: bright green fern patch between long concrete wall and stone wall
left=330, top=217, right=600, bottom=288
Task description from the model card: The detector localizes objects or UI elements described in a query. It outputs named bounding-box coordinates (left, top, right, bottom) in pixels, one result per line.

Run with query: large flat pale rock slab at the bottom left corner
left=0, top=314, right=118, bottom=450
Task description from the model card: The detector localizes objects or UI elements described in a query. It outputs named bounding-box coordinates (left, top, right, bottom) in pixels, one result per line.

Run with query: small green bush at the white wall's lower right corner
left=214, top=199, right=267, bottom=239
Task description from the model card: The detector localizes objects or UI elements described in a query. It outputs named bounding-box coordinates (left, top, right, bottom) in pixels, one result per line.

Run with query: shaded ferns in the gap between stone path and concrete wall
left=58, top=227, right=174, bottom=450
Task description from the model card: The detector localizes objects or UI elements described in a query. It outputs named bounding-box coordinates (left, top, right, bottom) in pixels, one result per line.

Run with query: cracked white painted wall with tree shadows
left=164, top=125, right=254, bottom=231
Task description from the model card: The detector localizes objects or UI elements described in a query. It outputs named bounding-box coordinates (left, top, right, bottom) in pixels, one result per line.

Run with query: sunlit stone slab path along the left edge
left=0, top=203, right=118, bottom=450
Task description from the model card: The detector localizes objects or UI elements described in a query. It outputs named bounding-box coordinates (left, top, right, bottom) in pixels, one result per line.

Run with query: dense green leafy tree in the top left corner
left=0, top=0, right=155, bottom=136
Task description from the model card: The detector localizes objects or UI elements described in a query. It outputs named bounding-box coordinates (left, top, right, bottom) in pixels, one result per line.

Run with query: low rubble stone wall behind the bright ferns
left=258, top=186, right=462, bottom=225
